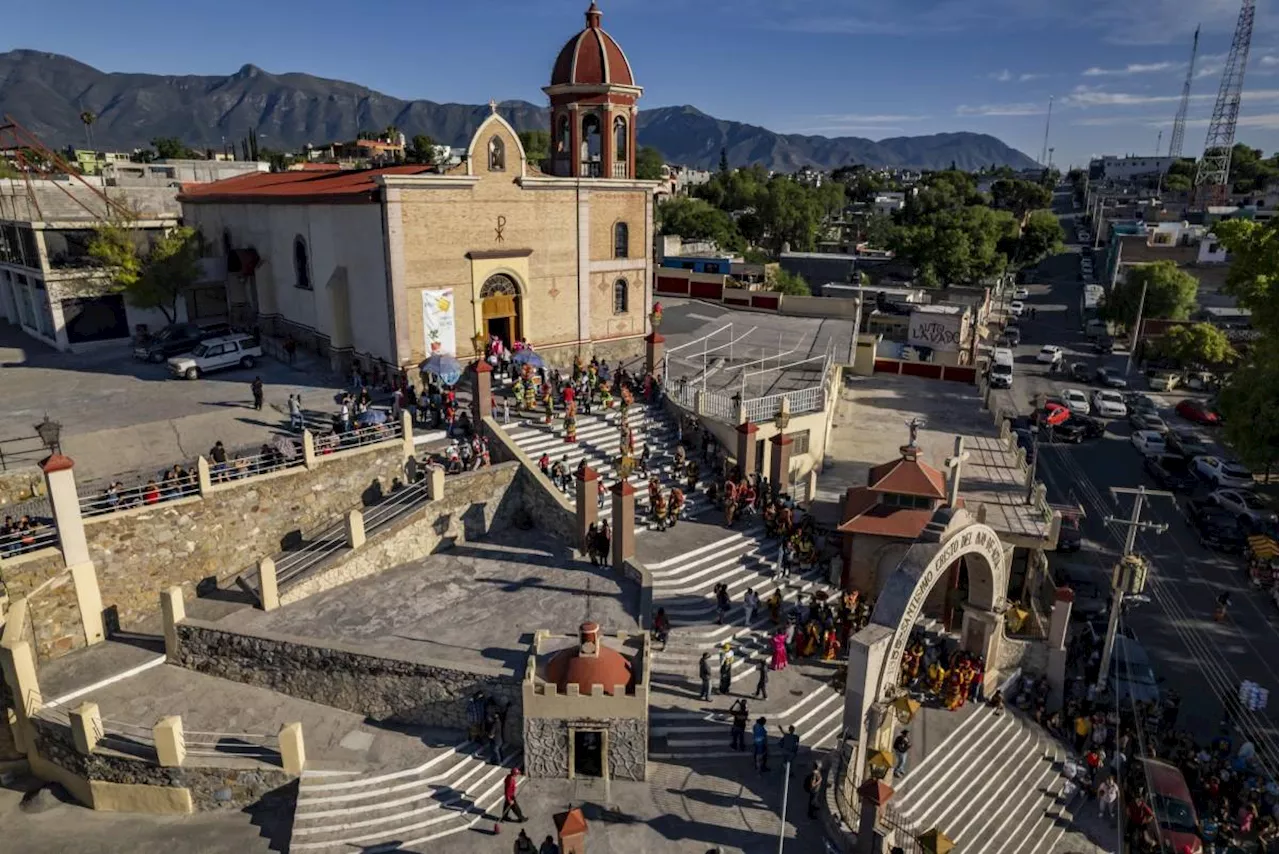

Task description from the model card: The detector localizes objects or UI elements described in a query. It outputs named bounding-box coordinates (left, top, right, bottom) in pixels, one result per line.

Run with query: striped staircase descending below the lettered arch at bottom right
left=891, top=704, right=1083, bottom=854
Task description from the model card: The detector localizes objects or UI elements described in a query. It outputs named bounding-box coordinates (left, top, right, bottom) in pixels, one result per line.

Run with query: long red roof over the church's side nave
left=178, top=163, right=431, bottom=204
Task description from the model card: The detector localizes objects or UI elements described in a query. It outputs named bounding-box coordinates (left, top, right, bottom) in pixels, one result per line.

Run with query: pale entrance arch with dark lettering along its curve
left=841, top=507, right=1009, bottom=787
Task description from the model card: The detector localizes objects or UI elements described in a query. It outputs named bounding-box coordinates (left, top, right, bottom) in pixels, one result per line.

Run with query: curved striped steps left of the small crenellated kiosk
left=289, top=741, right=520, bottom=854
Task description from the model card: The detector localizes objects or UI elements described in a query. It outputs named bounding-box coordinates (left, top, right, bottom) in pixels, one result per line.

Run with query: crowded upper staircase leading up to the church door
left=494, top=403, right=710, bottom=531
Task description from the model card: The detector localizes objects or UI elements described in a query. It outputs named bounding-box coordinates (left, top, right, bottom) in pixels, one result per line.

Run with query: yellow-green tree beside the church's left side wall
left=88, top=223, right=200, bottom=323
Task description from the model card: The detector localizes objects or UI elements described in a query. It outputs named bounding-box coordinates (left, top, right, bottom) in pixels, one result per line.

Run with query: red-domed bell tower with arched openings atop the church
left=543, top=0, right=644, bottom=179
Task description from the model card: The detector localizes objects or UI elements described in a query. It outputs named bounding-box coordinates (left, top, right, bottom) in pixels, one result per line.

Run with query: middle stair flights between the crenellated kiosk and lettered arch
left=649, top=526, right=844, bottom=762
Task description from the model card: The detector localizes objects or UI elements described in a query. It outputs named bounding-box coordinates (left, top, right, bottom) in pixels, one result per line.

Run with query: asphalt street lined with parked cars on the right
left=992, top=195, right=1280, bottom=775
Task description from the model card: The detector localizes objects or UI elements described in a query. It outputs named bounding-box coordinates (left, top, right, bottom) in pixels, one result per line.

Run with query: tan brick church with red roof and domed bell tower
left=179, top=3, right=657, bottom=373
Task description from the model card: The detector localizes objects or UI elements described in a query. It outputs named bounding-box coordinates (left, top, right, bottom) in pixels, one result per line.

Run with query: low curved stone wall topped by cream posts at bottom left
left=32, top=717, right=293, bottom=812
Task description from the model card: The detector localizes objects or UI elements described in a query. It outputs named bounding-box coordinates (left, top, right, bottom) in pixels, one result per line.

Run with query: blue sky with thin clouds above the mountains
left=0, top=0, right=1280, bottom=165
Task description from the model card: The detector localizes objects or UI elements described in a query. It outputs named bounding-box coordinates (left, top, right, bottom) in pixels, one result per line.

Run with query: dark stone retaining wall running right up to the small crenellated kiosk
left=177, top=620, right=524, bottom=741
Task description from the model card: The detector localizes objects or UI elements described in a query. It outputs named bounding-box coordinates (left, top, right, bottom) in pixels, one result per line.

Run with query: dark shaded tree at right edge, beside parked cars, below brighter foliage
left=1217, top=339, right=1280, bottom=474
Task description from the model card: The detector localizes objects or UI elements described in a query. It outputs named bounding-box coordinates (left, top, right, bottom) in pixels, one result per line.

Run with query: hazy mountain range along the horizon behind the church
left=0, top=50, right=1036, bottom=172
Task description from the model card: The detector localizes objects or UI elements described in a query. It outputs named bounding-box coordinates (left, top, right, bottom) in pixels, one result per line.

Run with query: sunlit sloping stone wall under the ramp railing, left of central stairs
left=280, top=462, right=520, bottom=604
